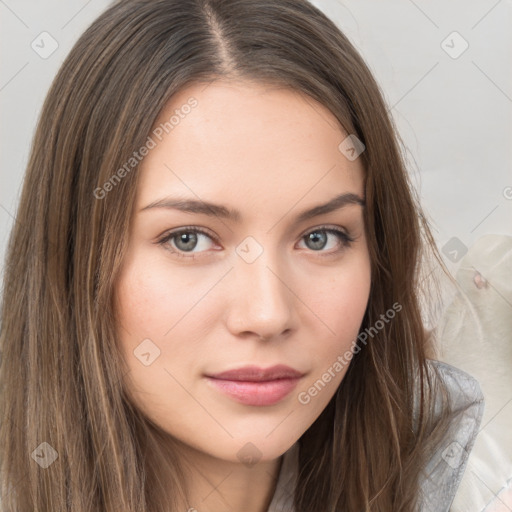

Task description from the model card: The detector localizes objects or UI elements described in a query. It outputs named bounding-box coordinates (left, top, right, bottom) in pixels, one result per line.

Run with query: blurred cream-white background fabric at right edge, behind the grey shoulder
left=433, top=234, right=512, bottom=512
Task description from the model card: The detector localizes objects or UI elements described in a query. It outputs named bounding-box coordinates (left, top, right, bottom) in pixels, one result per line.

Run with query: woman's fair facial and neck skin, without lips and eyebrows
left=116, top=80, right=370, bottom=512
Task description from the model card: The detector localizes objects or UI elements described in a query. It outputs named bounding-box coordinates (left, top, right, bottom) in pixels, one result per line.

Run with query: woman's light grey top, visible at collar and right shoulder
left=268, top=360, right=484, bottom=512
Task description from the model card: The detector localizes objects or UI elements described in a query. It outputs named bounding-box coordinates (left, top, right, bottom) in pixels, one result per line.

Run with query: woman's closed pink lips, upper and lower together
left=205, top=365, right=304, bottom=406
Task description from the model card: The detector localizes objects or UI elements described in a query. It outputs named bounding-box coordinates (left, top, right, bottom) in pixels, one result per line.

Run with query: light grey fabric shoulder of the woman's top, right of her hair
left=420, top=360, right=484, bottom=512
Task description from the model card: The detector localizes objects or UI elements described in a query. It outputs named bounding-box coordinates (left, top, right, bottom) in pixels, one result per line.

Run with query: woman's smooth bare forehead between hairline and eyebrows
left=137, top=81, right=364, bottom=214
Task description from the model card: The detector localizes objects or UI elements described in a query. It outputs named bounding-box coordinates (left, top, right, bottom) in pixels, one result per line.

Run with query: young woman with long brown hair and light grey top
left=0, top=0, right=483, bottom=512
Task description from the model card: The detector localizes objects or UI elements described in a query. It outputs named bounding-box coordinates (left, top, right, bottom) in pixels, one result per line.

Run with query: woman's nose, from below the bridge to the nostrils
left=226, top=246, right=297, bottom=340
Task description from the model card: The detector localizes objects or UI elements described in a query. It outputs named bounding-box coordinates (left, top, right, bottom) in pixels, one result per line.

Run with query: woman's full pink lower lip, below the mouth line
left=207, top=377, right=300, bottom=406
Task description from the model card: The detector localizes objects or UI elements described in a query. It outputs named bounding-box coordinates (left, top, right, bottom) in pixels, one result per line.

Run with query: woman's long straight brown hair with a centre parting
left=0, top=0, right=452, bottom=512
